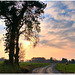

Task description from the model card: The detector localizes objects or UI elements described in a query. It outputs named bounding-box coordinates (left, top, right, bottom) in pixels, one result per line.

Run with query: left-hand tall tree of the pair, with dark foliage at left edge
left=0, top=1, right=15, bottom=63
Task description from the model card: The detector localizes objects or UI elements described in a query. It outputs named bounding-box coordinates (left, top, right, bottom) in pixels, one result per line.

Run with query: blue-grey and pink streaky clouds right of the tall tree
left=40, top=1, right=75, bottom=48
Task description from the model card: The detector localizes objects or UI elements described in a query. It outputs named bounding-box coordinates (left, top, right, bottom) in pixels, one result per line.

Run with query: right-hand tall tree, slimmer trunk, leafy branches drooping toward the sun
left=15, top=1, right=46, bottom=63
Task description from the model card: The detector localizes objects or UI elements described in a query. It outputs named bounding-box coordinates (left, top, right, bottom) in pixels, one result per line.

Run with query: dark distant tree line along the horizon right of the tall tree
left=29, top=57, right=75, bottom=63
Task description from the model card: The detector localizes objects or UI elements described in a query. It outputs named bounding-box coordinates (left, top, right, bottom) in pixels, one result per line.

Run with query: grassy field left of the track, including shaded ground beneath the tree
left=0, top=62, right=50, bottom=73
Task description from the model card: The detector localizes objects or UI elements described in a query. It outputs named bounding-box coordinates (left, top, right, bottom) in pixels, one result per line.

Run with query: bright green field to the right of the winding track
left=56, top=63, right=75, bottom=73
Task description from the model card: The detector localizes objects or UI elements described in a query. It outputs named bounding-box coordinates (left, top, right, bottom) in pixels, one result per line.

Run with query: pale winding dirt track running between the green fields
left=32, top=64, right=60, bottom=73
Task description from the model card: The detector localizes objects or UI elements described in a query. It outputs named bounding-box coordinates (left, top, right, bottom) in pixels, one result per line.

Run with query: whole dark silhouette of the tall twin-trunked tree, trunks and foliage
left=0, top=1, right=46, bottom=64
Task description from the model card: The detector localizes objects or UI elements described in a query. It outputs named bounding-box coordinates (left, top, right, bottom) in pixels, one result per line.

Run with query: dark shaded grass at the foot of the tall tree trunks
left=0, top=62, right=21, bottom=73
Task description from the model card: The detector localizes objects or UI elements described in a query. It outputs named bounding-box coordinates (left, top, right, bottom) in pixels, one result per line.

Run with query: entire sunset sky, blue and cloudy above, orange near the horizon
left=0, top=1, right=75, bottom=60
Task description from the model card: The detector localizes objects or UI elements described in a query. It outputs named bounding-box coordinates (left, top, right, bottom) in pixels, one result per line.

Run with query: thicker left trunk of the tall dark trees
left=9, top=23, right=15, bottom=64
